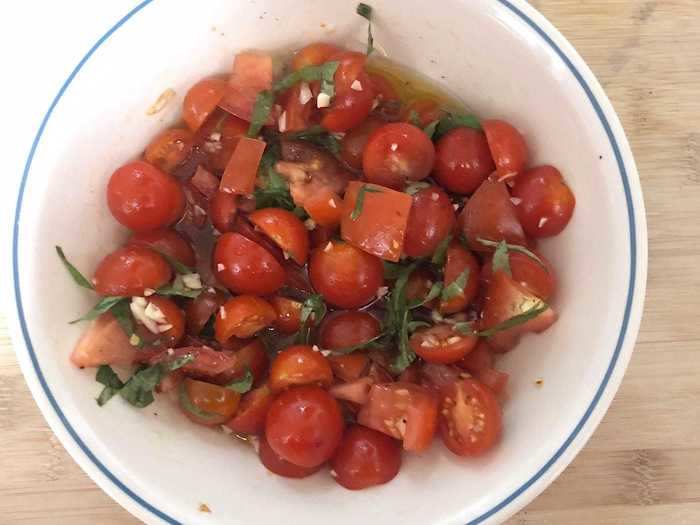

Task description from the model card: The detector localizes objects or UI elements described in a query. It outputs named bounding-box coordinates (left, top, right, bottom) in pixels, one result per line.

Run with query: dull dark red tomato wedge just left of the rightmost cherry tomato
left=459, top=180, right=527, bottom=251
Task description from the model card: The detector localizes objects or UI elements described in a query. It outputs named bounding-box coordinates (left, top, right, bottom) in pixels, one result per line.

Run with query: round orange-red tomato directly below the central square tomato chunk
left=309, top=242, right=384, bottom=308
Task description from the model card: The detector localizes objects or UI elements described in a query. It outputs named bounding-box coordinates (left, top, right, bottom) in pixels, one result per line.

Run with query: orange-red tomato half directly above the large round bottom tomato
left=268, top=345, right=333, bottom=392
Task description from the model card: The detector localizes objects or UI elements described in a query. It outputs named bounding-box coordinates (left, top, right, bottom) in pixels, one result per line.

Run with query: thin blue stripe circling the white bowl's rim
left=12, top=0, right=637, bottom=525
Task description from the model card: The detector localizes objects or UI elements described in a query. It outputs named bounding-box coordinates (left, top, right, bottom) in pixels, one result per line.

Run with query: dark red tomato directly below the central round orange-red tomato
left=318, top=311, right=382, bottom=350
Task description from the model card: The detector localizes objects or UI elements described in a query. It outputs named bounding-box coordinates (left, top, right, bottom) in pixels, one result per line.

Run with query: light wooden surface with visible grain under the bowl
left=0, top=0, right=700, bottom=525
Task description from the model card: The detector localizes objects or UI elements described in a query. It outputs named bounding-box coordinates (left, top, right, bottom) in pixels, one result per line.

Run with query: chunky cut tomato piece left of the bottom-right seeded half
left=357, top=383, right=438, bottom=452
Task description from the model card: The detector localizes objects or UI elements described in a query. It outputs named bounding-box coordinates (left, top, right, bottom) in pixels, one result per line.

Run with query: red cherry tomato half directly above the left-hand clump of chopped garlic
left=92, top=245, right=172, bottom=296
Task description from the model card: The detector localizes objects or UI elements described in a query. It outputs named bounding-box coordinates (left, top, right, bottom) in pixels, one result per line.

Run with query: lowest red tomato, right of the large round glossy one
left=331, top=425, right=401, bottom=490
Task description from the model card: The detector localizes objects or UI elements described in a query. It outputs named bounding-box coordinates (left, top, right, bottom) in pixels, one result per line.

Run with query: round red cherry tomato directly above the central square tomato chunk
left=362, top=122, right=435, bottom=189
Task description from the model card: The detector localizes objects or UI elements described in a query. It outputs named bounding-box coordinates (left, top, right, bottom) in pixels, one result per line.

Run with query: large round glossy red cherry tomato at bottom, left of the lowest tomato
left=265, top=386, right=343, bottom=468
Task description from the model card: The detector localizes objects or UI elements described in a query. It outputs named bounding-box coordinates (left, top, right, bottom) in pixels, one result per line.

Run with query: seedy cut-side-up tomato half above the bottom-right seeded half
left=409, top=324, right=479, bottom=364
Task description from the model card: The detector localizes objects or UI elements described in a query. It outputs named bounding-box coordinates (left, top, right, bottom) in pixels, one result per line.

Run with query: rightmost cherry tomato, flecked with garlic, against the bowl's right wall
left=512, top=166, right=576, bottom=239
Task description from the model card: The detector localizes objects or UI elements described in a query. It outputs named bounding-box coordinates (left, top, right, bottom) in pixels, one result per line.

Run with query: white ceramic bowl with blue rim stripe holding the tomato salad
left=13, top=0, right=647, bottom=525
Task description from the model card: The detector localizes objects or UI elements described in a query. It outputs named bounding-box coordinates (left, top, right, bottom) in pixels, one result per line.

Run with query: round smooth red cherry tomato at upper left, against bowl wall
left=107, top=160, right=185, bottom=232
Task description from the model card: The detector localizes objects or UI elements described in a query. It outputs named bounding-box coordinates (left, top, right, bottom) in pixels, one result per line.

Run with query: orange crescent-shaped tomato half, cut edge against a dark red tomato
left=248, top=208, right=309, bottom=266
